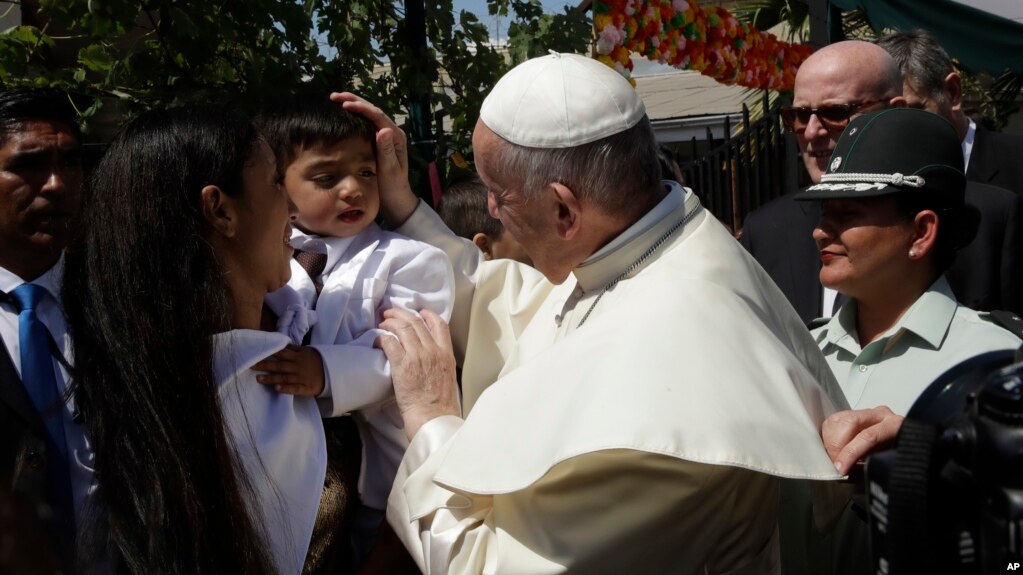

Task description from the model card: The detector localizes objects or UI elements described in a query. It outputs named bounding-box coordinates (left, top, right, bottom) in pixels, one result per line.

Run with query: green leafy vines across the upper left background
left=0, top=0, right=591, bottom=161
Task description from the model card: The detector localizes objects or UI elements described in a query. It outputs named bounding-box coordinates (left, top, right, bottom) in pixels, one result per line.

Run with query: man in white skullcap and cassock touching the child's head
left=337, top=54, right=844, bottom=574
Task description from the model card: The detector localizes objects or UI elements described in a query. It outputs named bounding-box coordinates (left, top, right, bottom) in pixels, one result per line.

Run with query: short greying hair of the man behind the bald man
left=877, top=30, right=955, bottom=102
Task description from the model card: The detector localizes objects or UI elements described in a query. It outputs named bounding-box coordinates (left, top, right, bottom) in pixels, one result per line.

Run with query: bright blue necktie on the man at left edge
left=10, top=283, right=74, bottom=519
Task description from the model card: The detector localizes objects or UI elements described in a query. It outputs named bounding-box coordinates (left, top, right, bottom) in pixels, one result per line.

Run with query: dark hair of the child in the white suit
left=256, top=93, right=376, bottom=171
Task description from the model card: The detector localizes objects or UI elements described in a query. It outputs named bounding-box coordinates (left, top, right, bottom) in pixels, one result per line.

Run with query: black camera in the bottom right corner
left=866, top=348, right=1023, bottom=575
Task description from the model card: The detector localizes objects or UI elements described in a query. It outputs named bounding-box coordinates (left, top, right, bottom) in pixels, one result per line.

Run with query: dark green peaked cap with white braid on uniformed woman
left=796, top=107, right=966, bottom=202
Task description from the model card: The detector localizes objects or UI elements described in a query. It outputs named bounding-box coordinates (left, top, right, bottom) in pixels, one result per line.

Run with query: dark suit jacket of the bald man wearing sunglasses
left=742, top=182, right=1023, bottom=321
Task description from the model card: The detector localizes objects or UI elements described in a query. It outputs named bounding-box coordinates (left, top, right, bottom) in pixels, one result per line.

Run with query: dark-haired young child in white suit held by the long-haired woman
left=254, top=95, right=454, bottom=558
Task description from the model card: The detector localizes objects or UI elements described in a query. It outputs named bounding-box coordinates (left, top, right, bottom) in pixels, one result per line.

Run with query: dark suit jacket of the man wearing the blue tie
left=0, top=331, right=74, bottom=557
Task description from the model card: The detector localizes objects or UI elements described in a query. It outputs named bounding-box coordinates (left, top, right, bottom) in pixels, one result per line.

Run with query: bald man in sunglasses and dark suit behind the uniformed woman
left=742, top=41, right=1023, bottom=322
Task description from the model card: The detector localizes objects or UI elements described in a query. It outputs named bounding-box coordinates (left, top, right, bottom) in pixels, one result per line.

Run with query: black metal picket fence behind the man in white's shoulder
left=681, top=92, right=798, bottom=232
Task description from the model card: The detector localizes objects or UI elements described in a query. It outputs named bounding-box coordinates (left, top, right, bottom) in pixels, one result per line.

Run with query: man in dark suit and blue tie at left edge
left=0, top=89, right=85, bottom=557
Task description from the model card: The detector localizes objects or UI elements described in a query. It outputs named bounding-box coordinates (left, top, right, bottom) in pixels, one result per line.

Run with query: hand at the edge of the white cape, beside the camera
left=820, top=405, right=903, bottom=475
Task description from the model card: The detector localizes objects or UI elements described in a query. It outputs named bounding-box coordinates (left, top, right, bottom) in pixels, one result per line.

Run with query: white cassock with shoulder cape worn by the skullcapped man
left=388, top=185, right=846, bottom=574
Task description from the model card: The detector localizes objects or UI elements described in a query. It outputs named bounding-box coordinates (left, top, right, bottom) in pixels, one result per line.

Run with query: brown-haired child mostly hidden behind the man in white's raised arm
left=440, top=174, right=533, bottom=265
